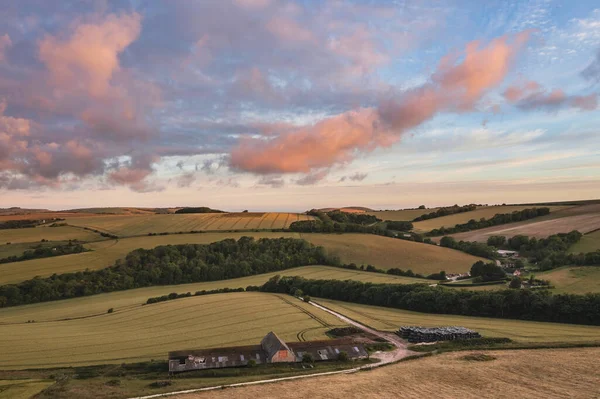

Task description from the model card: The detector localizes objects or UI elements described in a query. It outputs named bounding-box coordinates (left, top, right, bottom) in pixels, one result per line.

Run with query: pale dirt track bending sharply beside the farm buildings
left=129, top=299, right=415, bottom=399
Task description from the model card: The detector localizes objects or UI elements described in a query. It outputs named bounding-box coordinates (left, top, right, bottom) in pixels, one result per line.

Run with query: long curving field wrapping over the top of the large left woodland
left=0, top=232, right=479, bottom=285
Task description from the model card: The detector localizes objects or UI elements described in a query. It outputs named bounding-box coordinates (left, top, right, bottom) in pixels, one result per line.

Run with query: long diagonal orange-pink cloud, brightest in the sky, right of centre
left=230, top=32, right=529, bottom=174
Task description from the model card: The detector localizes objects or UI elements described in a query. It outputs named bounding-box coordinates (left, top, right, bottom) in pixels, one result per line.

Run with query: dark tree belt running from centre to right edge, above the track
left=261, top=276, right=600, bottom=325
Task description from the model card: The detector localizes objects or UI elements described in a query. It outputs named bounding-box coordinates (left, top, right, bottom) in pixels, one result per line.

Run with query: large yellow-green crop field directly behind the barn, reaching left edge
left=0, top=292, right=343, bottom=369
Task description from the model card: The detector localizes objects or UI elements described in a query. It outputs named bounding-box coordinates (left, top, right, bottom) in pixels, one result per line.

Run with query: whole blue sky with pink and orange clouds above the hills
left=0, top=0, right=600, bottom=211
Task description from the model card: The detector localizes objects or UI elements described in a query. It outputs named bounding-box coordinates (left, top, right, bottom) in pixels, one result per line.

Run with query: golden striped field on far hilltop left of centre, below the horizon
left=67, top=213, right=313, bottom=237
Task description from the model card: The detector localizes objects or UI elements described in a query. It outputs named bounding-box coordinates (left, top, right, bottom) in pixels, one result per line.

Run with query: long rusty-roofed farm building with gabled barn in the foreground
left=169, top=332, right=368, bottom=373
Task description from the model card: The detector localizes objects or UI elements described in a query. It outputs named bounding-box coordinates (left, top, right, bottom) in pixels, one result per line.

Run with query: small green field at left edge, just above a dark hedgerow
left=0, top=226, right=102, bottom=244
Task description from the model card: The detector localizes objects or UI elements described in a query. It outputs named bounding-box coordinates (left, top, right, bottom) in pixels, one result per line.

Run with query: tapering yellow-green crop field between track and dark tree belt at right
left=316, top=299, right=600, bottom=342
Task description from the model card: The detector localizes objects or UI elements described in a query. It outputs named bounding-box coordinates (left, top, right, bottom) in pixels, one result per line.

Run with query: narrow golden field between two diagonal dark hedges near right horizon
left=414, top=205, right=568, bottom=232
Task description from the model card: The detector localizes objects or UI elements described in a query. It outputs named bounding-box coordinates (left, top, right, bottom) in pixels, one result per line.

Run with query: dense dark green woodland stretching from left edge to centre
left=0, top=237, right=337, bottom=307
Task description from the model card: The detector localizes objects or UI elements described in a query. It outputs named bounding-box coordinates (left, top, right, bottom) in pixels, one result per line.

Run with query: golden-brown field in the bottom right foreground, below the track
left=184, top=348, right=600, bottom=399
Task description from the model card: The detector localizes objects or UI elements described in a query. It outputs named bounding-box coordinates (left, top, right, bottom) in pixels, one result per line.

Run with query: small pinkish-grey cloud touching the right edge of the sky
left=504, top=82, right=598, bottom=111
